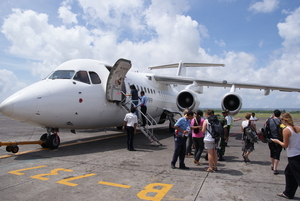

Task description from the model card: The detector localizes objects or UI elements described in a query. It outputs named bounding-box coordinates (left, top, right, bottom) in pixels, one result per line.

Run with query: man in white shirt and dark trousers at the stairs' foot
left=123, top=107, right=137, bottom=151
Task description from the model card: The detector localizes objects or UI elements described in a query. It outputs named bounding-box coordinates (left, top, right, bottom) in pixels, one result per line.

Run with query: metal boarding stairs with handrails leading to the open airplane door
left=119, top=92, right=162, bottom=146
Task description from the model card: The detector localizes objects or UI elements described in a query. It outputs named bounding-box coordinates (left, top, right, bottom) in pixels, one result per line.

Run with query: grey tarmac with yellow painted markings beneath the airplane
left=0, top=115, right=300, bottom=201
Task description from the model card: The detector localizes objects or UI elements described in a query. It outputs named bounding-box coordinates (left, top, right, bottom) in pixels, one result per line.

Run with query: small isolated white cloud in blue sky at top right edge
left=249, top=0, right=279, bottom=13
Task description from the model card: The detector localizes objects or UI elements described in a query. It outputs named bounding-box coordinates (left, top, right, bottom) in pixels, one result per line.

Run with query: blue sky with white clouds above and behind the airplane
left=0, top=0, right=300, bottom=108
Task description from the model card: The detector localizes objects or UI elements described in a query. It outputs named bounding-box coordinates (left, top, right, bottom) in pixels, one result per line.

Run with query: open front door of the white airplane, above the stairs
left=106, top=59, right=131, bottom=102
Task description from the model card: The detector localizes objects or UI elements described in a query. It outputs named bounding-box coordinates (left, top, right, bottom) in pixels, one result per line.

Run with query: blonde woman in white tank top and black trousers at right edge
left=271, top=113, right=300, bottom=199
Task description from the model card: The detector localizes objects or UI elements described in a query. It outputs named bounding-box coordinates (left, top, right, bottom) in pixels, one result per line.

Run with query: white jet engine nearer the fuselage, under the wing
left=176, top=89, right=200, bottom=111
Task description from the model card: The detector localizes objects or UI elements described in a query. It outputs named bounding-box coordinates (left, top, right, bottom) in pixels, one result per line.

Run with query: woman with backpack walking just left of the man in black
left=241, top=112, right=256, bottom=163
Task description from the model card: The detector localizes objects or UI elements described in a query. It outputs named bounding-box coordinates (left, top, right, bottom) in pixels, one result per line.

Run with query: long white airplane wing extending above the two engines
left=153, top=75, right=300, bottom=92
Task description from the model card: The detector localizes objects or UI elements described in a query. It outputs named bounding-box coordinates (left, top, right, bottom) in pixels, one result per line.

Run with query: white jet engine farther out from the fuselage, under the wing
left=221, top=93, right=242, bottom=115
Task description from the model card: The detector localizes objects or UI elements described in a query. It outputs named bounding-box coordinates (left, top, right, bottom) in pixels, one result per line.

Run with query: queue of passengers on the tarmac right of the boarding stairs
left=171, top=110, right=300, bottom=199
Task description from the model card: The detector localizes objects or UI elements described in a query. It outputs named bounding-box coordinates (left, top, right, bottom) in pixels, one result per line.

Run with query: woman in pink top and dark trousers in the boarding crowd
left=191, top=110, right=204, bottom=165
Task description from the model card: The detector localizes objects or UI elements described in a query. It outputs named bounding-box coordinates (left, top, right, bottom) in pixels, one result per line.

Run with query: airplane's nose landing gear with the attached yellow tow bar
left=0, top=128, right=60, bottom=153
